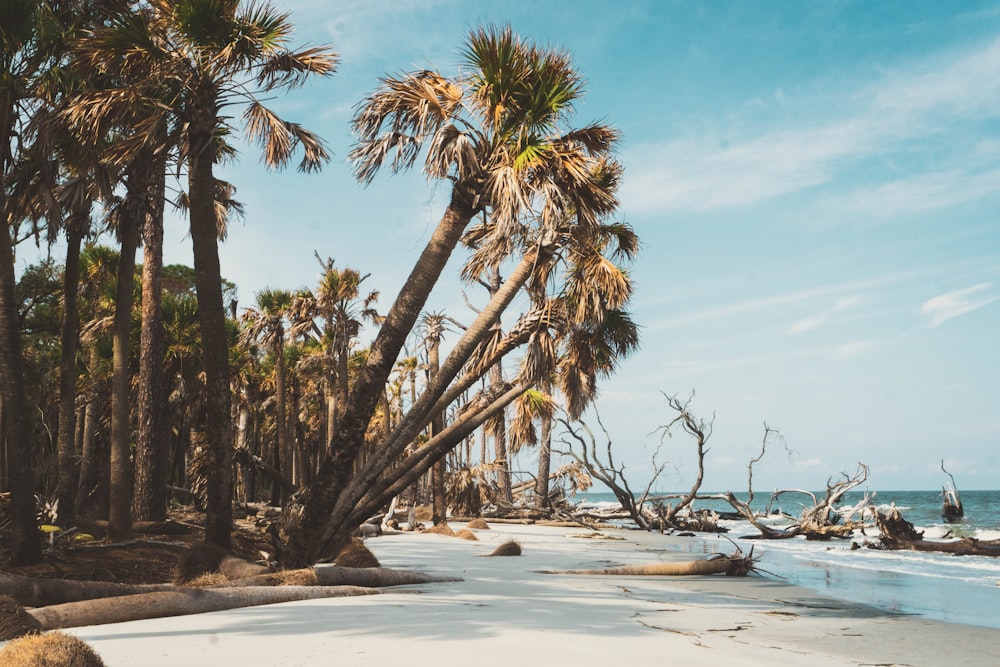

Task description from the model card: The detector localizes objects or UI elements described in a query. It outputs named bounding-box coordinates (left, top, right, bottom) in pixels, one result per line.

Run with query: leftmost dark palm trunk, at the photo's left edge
left=0, top=222, right=42, bottom=565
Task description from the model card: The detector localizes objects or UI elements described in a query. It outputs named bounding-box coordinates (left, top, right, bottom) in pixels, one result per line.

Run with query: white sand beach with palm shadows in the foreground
left=70, top=524, right=1000, bottom=667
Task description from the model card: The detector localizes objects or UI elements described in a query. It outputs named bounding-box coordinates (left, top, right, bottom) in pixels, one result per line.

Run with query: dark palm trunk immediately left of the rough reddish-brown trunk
left=108, top=201, right=144, bottom=539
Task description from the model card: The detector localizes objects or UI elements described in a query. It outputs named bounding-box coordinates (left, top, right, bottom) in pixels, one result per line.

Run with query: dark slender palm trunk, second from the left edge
left=56, top=214, right=90, bottom=523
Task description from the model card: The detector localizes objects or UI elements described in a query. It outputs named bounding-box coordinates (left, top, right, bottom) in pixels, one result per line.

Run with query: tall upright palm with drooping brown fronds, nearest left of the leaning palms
left=69, top=0, right=337, bottom=547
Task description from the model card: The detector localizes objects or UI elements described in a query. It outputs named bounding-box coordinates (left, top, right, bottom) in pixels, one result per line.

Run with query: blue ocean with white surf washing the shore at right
left=574, top=490, right=1000, bottom=628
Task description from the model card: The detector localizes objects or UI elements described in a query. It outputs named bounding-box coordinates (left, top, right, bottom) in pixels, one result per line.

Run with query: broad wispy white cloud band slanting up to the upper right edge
left=622, top=39, right=1000, bottom=212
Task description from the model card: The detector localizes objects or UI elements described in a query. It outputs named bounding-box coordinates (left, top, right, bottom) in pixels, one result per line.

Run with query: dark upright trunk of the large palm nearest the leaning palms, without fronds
left=188, top=128, right=233, bottom=549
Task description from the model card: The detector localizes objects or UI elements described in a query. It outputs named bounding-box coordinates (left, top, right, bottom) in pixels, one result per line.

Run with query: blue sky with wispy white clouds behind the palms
left=27, top=0, right=1000, bottom=491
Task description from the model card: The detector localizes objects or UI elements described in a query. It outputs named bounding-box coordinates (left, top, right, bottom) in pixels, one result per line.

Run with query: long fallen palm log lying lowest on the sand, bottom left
left=27, top=586, right=379, bottom=630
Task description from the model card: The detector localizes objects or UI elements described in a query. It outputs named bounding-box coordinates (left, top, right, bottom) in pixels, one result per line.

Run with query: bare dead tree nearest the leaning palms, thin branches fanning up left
left=556, top=415, right=664, bottom=530
